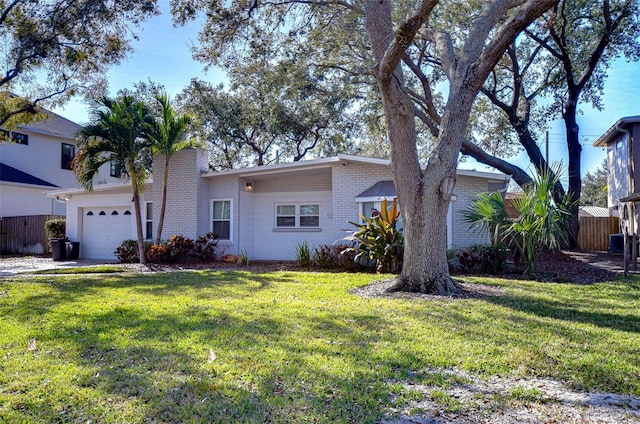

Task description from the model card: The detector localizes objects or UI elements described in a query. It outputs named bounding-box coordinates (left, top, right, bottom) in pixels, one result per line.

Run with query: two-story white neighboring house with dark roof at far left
left=0, top=110, right=119, bottom=218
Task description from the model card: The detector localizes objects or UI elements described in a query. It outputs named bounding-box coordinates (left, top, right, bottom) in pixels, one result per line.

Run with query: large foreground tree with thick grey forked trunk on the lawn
left=171, top=0, right=558, bottom=294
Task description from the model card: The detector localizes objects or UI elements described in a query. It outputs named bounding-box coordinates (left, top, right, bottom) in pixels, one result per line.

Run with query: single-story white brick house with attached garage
left=48, top=149, right=509, bottom=260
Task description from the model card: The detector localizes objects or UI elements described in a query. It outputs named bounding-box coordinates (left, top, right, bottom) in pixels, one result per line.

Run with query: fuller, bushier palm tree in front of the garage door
left=73, top=95, right=153, bottom=263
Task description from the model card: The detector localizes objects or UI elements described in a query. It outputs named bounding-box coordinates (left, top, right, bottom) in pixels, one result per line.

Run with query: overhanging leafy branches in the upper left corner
left=0, top=0, right=157, bottom=128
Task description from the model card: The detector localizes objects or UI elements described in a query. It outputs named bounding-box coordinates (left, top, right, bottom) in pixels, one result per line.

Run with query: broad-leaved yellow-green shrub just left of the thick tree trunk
left=345, top=199, right=404, bottom=272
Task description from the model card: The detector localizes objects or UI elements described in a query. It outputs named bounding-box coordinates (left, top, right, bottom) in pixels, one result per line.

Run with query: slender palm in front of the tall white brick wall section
left=148, top=93, right=193, bottom=244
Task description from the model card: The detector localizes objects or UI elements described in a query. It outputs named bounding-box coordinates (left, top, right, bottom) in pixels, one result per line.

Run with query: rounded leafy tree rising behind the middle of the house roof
left=179, top=48, right=354, bottom=169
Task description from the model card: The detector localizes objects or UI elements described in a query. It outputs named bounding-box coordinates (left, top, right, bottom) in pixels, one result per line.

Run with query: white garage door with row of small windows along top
left=80, top=206, right=133, bottom=259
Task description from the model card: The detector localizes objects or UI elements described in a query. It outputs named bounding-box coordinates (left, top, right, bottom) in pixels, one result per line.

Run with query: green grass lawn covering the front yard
left=0, top=271, right=640, bottom=423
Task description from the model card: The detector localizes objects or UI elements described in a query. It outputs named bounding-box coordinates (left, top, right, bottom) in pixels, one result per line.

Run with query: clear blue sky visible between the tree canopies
left=55, top=0, right=640, bottom=173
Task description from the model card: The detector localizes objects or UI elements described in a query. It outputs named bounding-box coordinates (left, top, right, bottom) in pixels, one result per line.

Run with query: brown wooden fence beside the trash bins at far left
left=0, top=215, right=64, bottom=255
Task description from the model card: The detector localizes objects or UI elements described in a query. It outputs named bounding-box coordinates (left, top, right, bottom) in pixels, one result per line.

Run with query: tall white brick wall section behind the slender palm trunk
left=152, top=148, right=208, bottom=239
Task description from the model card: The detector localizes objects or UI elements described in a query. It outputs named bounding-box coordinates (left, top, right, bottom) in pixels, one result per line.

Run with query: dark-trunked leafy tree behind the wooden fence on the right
left=462, top=0, right=640, bottom=241
